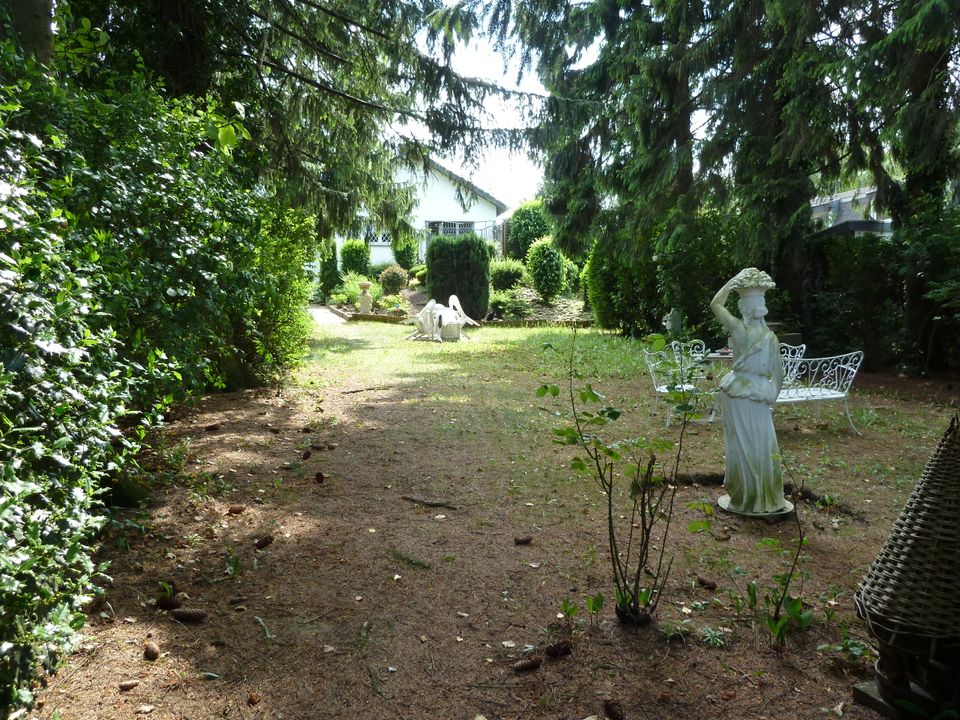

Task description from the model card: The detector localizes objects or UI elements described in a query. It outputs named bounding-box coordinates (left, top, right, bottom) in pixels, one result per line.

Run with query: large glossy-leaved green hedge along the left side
left=0, top=37, right=314, bottom=717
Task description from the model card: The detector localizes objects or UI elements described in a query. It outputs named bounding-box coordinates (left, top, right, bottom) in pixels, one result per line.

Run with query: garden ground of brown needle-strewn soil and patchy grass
left=34, top=323, right=955, bottom=720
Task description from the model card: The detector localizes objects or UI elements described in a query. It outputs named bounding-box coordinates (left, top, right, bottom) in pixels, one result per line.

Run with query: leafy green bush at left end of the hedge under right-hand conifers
left=586, top=233, right=659, bottom=337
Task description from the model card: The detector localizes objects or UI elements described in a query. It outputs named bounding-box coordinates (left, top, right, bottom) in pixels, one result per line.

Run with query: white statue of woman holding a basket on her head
left=710, top=268, right=793, bottom=516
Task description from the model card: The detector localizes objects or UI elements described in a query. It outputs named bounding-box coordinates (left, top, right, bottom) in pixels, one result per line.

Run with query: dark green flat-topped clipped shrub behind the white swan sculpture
left=427, top=233, right=490, bottom=319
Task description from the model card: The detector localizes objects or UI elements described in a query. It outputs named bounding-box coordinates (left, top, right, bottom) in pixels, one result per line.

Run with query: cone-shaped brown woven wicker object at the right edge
left=854, top=415, right=960, bottom=654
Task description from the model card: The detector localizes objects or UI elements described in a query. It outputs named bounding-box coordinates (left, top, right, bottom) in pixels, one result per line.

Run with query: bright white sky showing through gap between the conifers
left=436, top=38, right=545, bottom=209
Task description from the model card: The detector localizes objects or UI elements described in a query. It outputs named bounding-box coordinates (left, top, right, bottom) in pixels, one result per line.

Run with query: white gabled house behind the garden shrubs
left=337, top=161, right=507, bottom=264
